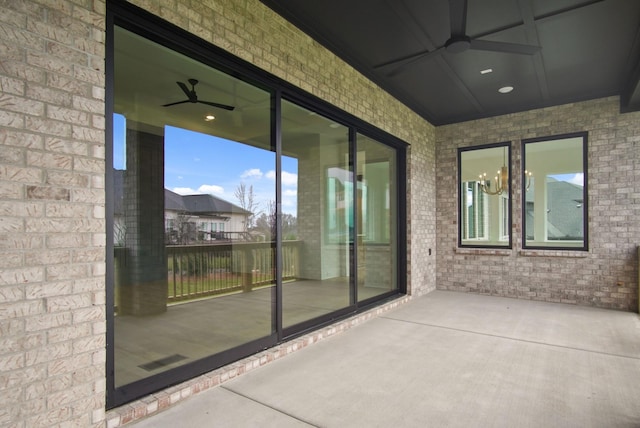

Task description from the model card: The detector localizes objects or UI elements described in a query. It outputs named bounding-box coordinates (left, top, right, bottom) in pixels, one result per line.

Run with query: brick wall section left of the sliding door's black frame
left=0, top=1, right=105, bottom=427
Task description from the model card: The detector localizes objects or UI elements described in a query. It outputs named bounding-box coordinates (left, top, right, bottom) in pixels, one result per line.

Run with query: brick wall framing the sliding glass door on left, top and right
left=0, top=0, right=435, bottom=427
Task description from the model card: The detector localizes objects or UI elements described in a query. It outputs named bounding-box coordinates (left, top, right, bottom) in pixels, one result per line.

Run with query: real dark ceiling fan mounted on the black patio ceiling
left=374, top=0, right=540, bottom=77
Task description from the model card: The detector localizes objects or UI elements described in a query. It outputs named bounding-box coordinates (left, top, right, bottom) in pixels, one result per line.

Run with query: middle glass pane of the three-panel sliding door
left=282, top=100, right=354, bottom=328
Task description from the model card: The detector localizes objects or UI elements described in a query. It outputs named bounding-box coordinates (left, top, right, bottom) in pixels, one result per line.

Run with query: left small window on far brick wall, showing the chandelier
left=458, top=143, right=511, bottom=248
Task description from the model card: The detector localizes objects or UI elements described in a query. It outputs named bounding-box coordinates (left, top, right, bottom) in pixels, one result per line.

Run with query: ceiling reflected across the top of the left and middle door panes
left=114, top=27, right=347, bottom=148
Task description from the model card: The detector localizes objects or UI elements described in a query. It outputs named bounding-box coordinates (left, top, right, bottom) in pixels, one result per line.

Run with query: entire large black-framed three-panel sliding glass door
left=106, top=9, right=404, bottom=407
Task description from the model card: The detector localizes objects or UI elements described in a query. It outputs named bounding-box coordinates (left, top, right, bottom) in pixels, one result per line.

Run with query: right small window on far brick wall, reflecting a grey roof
left=522, top=133, right=588, bottom=250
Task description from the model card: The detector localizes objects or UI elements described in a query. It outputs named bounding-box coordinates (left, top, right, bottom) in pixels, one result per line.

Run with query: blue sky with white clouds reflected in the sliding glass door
left=113, top=115, right=298, bottom=215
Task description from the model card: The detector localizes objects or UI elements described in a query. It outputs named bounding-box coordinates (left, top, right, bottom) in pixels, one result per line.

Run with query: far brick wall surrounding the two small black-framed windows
left=436, top=98, right=640, bottom=310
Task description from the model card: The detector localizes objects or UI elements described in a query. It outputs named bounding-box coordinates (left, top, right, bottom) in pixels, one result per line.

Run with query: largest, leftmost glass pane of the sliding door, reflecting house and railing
left=109, top=28, right=276, bottom=388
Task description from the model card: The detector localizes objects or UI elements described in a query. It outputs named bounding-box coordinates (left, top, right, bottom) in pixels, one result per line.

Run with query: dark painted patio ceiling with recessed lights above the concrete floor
left=261, top=0, right=640, bottom=125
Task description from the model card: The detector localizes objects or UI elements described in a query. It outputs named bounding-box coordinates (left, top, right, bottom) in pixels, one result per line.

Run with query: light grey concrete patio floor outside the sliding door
left=130, top=291, right=640, bottom=428
